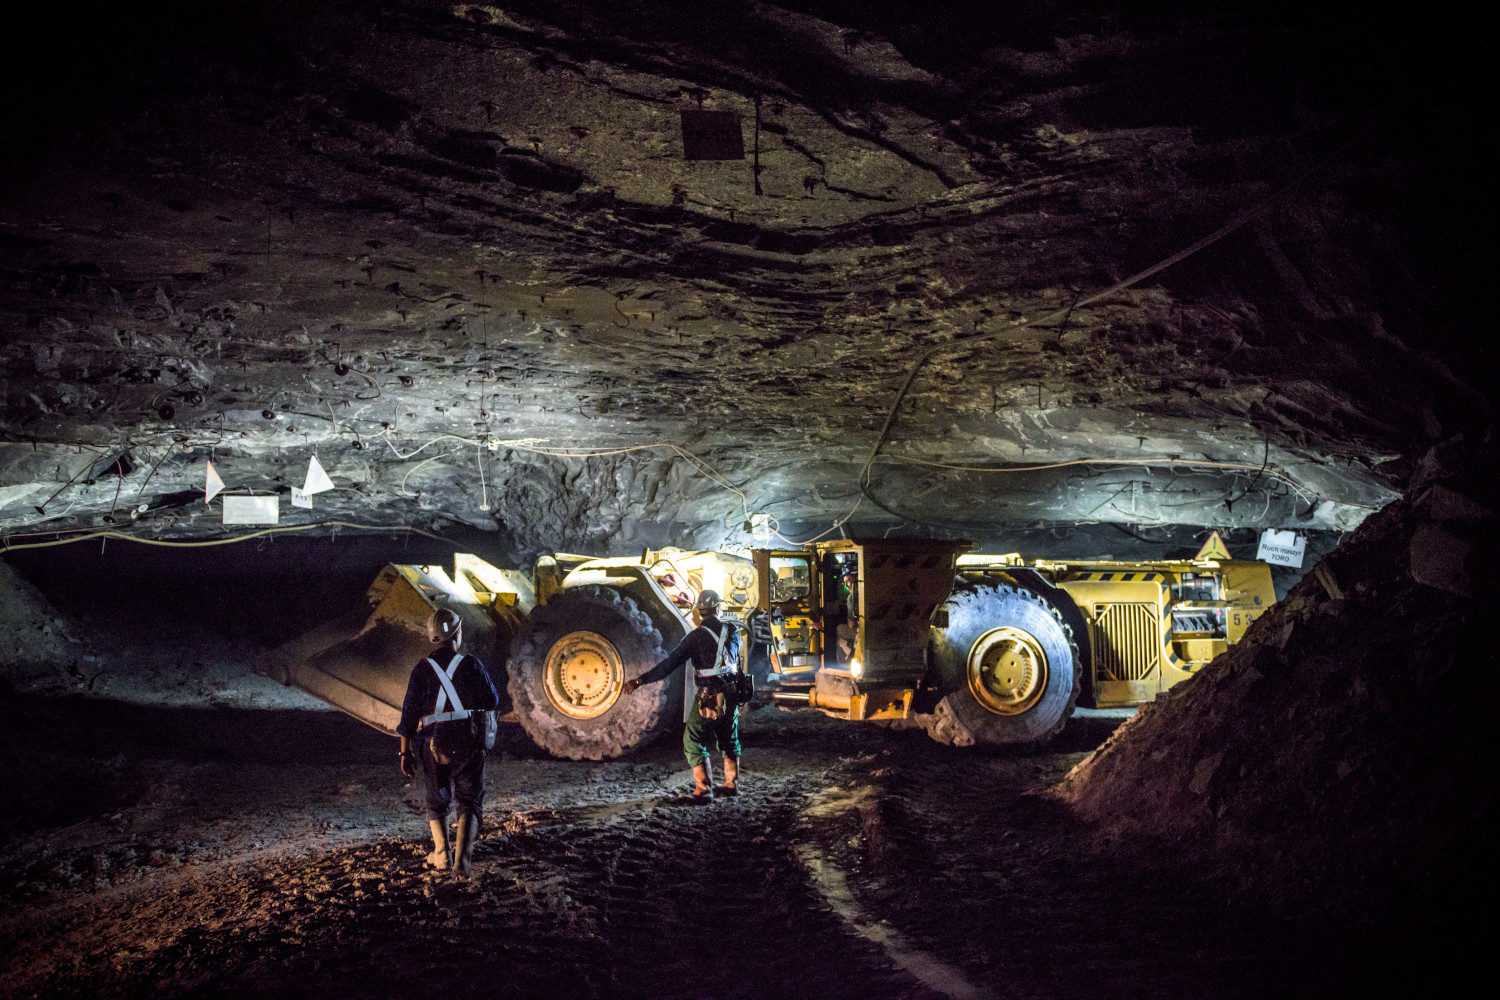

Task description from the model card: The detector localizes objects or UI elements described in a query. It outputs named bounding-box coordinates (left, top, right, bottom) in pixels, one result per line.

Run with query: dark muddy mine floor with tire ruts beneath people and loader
left=0, top=696, right=1392, bottom=1000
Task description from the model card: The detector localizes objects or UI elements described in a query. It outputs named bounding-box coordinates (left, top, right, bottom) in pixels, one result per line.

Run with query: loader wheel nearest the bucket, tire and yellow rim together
left=509, top=586, right=683, bottom=760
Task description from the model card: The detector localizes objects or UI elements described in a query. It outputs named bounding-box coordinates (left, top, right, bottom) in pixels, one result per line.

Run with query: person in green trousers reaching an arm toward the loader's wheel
left=626, top=591, right=740, bottom=802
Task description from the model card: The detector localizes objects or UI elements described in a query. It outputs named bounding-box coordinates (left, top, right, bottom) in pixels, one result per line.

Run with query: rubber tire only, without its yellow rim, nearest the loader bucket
left=507, top=586, right=683, bottom=760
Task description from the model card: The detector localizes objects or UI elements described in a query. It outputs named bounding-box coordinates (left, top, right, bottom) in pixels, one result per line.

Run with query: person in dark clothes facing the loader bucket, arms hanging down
left=396, top=609, right=500, bottom=879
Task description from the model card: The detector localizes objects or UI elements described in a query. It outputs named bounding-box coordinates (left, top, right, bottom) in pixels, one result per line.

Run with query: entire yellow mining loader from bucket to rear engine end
left=261, top=540, right=1275, bottom=760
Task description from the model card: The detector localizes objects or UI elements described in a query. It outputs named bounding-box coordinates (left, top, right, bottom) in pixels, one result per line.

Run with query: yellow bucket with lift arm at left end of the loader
left=257, top=555, right=530, bottom=735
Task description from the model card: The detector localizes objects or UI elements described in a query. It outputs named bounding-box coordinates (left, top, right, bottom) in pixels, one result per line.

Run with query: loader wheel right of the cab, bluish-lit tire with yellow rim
left=923, top=585, right=1083, bottom=747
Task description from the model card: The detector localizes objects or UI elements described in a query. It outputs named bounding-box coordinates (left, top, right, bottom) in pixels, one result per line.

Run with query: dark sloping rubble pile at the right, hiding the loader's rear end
left=1056, top=438, right=1500, bottom=946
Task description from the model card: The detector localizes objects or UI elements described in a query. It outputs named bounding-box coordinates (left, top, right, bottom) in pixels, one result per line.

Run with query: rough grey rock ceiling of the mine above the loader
left=0, top=1, right=1490, bottom=552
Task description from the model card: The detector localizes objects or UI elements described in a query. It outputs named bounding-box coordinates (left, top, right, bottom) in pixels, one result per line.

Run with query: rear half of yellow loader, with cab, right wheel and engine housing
left=755, top=540, right=1275, bottom=745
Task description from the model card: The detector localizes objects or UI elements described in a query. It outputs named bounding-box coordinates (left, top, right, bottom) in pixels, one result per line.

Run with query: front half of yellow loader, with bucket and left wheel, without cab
left=260, top=549, right=756, bottom=760
